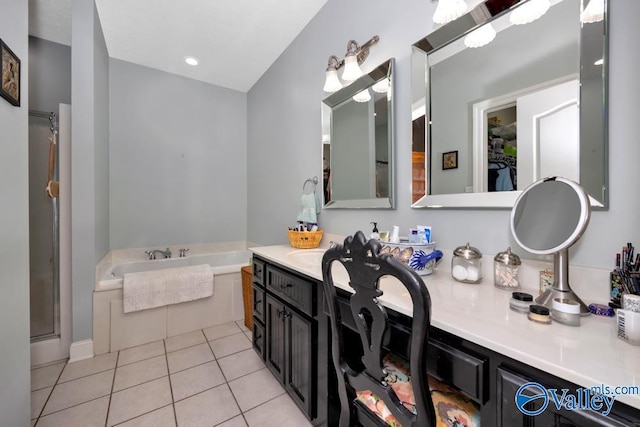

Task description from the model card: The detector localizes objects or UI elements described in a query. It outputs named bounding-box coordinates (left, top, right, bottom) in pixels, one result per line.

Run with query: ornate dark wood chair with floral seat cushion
left=322, top=231, right=436, bottom=427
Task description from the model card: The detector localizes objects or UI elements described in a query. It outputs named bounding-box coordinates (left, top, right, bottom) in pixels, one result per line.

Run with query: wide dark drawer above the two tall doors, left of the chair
left=266, top=265, right=316, bottom=317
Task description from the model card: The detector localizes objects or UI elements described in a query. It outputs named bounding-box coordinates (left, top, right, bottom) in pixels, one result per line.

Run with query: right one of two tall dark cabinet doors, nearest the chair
left=285, top=308, right=317, bottom=418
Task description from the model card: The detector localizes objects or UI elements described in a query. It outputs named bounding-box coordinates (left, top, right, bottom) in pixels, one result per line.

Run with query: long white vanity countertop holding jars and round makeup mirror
left=251, top=245, right=640, bottom=409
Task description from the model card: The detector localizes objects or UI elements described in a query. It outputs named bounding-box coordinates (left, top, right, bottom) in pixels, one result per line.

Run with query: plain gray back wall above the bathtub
left=109, top=59, right=248, bottom=249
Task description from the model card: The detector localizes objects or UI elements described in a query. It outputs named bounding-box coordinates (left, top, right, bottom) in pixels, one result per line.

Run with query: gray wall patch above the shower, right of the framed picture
left=29, top=36, right=71, bottom=114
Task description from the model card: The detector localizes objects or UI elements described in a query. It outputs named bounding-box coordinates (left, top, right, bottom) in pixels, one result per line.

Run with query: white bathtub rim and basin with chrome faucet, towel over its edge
left=95, top=250, right=251, bottom=292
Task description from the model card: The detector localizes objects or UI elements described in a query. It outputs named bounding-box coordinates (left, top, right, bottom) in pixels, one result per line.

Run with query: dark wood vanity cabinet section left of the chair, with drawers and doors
left=253, top=259, right=327, bottom=425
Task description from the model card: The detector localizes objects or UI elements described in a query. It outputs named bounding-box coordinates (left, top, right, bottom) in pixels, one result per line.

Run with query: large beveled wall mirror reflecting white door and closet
left=411, top=0, right=608, bottom=208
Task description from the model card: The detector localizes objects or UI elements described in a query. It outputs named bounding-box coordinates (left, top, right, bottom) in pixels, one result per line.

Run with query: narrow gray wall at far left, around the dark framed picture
left=0, top=0, right=31, bottom=427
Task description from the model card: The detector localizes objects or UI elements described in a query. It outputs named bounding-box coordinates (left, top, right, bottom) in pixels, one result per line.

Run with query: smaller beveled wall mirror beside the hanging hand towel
left=322, top=58, right=394, bottom=209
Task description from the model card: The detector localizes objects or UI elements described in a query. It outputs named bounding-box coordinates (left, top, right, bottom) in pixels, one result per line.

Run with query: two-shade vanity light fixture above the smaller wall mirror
left=323, top=36, right=380, bottom=92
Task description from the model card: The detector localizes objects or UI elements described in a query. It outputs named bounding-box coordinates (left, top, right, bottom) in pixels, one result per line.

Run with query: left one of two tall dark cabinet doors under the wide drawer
left=265, top=295, right=286, bottom=383
